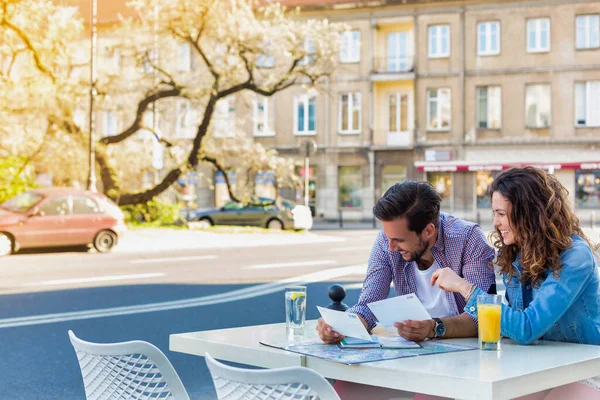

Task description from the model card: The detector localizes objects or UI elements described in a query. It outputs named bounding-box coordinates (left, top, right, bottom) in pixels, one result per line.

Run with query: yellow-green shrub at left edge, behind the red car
left=0, top=156, right=35, bottom=203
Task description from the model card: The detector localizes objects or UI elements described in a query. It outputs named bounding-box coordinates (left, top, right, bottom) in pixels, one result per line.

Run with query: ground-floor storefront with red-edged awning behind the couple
left=415, top=161, right=600, bottom=221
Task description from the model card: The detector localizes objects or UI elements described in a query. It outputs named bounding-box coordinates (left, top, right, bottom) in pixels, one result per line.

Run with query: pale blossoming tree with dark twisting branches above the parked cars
left=0, top=0, right=342, bottom=205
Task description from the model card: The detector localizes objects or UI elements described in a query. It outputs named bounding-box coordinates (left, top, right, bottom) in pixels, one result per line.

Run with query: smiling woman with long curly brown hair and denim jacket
left=431, top=167, right=600, bottom=399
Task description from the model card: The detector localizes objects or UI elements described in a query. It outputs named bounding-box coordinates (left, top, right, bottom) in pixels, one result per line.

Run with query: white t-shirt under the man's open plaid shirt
left=413, top=260, right=456, bottom=318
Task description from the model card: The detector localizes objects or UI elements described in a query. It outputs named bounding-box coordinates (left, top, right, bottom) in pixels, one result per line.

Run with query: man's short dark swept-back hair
left=373, top=181, right=442, bottom=235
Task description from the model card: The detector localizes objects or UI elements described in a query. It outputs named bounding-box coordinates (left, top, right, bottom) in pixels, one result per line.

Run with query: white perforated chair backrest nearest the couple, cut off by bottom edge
left=204, top=353, right=340, bottom=400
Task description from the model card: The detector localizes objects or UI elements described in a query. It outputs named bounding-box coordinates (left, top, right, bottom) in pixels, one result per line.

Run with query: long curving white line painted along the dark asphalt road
left=0, top=264, right=366, bottom=329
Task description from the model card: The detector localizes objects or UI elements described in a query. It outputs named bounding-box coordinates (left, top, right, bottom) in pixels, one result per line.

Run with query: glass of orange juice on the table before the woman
left=477, top=294, right=502, bottom=350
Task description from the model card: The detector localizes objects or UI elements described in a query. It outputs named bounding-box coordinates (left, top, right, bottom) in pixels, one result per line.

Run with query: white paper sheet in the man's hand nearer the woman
left=368, top=293, right=431, bottom=327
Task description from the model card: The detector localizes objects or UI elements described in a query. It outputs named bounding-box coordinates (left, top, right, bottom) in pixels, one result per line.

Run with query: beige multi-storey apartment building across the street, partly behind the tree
left=64, top=0, right=600, bottom=219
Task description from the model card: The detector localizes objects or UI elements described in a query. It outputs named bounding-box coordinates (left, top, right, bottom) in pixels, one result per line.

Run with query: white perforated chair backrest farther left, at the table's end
left=69, top=331, right=190, bottom=400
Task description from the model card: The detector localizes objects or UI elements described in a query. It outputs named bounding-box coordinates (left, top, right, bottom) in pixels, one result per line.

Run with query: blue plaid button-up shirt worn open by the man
left=348, top=213, right=495, bottom=330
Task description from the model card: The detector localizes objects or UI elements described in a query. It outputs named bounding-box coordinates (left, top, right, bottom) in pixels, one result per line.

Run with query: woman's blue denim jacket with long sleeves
left=465, top=235, right=600, bottom=345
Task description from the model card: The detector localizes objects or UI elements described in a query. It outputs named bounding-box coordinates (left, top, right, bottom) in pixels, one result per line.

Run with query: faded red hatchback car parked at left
left=0, top=188, right=125, bottom=256
